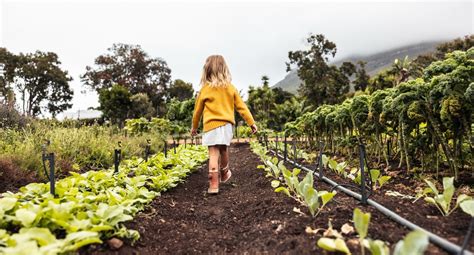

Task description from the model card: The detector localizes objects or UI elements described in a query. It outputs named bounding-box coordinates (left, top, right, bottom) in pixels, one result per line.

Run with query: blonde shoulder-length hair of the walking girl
left=201, top=55, right=232, bottom=87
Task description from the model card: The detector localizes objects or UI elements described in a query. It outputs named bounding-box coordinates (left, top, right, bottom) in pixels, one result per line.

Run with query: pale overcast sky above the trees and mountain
left=0, top=0, right=473, bottom=116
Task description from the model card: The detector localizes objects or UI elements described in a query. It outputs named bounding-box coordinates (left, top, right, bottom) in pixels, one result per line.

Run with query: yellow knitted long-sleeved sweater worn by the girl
left=193, top=84, right=255, bottom=132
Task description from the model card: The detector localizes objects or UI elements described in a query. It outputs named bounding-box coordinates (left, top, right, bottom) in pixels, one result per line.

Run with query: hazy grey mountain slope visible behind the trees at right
left=273, top=41, right=442, bottom=93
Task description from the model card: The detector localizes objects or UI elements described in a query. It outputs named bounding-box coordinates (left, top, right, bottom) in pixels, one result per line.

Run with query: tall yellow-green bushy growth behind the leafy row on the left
left=0, top=121, right=163, bottom=177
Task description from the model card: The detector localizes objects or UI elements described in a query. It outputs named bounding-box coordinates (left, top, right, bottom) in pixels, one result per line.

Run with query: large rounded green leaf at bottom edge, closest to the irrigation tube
left=393, top=231, right=429, bottom=255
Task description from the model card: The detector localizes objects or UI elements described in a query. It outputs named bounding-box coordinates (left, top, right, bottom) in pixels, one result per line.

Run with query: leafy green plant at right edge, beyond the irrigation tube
left=415, top=177, right=472, bottom=216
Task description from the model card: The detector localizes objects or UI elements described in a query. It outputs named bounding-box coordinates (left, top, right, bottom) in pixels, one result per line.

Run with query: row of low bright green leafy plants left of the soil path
left=0, top=143, right=207, bottom=254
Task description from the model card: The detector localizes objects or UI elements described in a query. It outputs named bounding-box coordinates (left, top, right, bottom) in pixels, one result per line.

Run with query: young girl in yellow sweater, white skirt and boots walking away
left=191, top=55, right=257, bottom=194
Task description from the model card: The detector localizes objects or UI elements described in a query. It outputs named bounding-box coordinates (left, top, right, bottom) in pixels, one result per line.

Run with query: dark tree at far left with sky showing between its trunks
left=14, top=51, right=73, bottom=117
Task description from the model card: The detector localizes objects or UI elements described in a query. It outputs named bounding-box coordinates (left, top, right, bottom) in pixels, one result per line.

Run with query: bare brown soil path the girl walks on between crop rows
left=81, top=144, right=467, bottom=254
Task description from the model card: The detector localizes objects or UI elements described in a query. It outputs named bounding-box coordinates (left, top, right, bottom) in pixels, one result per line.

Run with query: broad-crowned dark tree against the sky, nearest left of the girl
left=81, top=44, right=171, bottom=114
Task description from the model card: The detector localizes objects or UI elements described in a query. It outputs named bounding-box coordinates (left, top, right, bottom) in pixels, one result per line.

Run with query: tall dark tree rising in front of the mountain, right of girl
left=286, top=34, right=353, bottom=106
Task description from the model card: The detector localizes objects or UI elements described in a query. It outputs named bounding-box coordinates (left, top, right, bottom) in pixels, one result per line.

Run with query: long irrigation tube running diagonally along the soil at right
left=269, top=147, right=474, bottom=255
